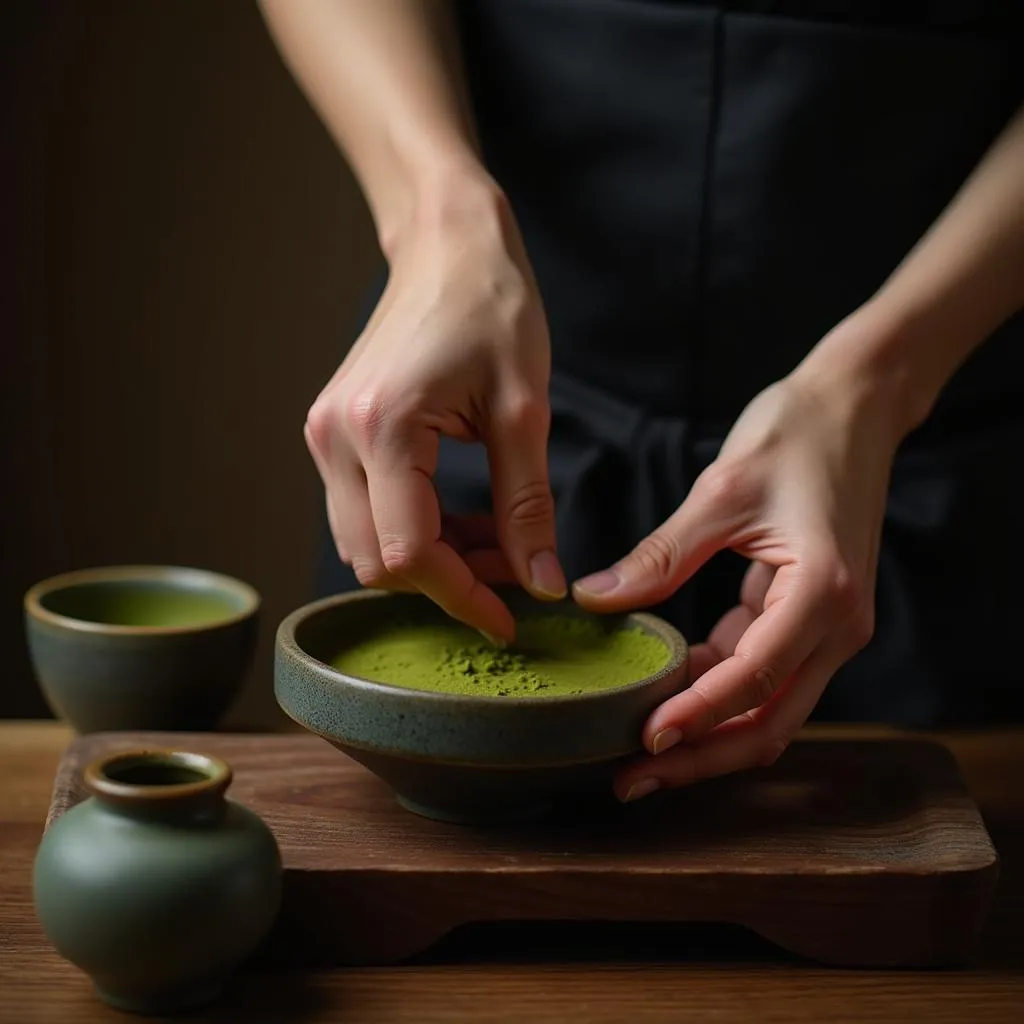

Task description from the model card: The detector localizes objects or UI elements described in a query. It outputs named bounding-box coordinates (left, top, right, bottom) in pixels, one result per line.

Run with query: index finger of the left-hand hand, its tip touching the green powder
left=367, top=446, right=515, bottom=641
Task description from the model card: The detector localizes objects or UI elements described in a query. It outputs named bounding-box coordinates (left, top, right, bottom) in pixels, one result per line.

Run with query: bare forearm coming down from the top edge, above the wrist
left=260, top=0, right=493, bottom=255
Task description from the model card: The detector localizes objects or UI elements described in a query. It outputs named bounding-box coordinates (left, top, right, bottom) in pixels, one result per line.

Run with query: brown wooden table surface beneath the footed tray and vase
left=0, top=723, right=1024, bottom=1024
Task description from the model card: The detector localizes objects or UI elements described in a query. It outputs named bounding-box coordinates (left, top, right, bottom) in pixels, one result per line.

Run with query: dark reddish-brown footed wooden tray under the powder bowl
left=48, top=733, right=998, bottom=967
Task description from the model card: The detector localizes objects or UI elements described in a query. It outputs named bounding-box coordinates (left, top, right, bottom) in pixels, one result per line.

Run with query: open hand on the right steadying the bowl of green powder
left=573, top=356, right=900, bottom=800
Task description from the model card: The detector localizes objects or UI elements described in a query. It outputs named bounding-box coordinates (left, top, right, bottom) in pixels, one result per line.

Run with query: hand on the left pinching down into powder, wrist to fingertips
left=305, top=183, right=565, bottom=641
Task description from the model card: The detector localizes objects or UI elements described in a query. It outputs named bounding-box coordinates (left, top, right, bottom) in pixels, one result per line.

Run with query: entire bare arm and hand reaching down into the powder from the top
left=256, top=0, right=565, bottom=641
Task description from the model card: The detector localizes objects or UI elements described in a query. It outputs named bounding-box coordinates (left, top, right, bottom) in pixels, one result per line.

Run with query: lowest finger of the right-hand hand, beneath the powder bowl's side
left=614, top=643, right=846, bottom=801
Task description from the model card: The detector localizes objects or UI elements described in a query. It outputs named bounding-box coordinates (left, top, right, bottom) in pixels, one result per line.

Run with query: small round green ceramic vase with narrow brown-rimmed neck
left=33, top=751, right=282, bottom=1013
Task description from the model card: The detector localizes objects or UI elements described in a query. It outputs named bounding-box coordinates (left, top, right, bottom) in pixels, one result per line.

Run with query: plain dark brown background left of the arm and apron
left=0, top=0, right=377, bottom=725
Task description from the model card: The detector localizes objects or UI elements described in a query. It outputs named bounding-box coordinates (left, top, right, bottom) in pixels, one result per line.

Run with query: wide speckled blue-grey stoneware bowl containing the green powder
left=274, top=591, right=689, bottom=823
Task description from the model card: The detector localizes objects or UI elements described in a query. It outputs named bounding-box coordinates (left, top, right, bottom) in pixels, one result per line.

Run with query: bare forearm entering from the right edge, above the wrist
left=802, top=108, right=1024, bottom=433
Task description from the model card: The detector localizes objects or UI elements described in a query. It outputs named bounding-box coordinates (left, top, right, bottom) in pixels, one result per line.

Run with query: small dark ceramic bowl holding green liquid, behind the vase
left=25, top=565, right=260, bottom=733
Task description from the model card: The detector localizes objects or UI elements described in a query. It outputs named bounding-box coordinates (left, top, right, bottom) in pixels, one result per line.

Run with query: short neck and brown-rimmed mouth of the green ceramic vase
left=84, top=750, right=231, bottom=825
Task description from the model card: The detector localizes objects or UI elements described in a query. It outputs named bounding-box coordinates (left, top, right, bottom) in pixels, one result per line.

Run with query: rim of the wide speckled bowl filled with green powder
left=275, top=589, right=690, bottom=708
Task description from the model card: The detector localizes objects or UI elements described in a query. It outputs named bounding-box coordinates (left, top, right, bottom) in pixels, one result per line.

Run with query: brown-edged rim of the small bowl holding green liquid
left=24, top=564, right=262, bottom=637
